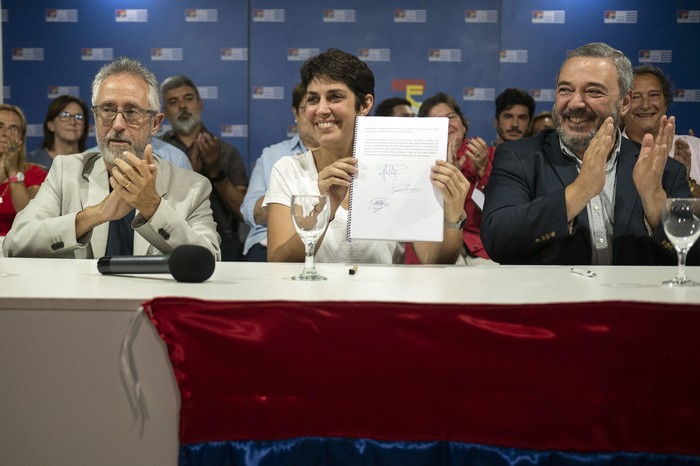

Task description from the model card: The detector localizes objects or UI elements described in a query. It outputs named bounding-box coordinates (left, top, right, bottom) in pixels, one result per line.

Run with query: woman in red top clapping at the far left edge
left=0, top=104, right=46, bottom=237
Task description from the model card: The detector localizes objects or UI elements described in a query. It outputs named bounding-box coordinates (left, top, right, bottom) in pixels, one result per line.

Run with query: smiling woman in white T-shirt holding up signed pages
left=264, top=49, right=469, bottom=264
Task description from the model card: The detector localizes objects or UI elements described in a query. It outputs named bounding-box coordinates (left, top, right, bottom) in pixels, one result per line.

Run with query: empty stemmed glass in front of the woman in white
left=290, top=195, right=330, bottom=280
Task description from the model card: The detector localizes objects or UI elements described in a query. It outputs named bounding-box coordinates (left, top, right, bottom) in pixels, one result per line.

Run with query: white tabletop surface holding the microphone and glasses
left=0, top=258, right=700, bottom=311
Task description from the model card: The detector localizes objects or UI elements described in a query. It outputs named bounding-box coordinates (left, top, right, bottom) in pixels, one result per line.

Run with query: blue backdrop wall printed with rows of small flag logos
left=2, top=0, right=700, bottom=171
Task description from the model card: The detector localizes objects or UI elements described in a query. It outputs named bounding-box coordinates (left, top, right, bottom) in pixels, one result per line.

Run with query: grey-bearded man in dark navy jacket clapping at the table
left=481, top=43, right=700, bottom=265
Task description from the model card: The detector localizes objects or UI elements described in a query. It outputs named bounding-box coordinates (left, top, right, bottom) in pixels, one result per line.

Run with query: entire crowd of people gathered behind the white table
left=0, top=43, right=700, bottom=265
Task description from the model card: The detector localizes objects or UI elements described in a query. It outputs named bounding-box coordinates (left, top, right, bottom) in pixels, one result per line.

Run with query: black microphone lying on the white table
left=97, top=244, right=216, bottom=283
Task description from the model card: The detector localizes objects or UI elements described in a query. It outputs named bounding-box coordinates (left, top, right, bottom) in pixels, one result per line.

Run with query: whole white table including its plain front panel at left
left=0, top=258, right=700, bottom=466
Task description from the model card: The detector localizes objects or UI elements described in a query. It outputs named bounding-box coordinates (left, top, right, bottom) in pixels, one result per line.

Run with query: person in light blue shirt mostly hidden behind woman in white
left=241, top=84, right=316, bottom=262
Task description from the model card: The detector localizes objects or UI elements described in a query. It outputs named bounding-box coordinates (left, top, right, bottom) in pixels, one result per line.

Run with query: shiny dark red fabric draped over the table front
left=145, top=298, right=700, bottom=455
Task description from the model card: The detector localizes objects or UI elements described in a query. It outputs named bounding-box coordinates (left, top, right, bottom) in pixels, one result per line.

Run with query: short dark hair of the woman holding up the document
left=301, top=49, right=374, bottom=112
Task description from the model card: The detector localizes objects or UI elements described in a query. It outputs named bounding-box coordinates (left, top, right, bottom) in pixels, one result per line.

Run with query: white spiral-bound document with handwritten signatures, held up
left=348, top=116, right=448, bottom=241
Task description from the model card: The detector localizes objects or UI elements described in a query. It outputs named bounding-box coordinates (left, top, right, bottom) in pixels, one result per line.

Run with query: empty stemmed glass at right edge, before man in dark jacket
left=661, top=198, right=700, bottom=286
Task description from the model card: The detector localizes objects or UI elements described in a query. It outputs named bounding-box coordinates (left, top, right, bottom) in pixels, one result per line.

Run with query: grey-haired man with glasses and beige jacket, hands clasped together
left=3, top=58, right=220, bottom=260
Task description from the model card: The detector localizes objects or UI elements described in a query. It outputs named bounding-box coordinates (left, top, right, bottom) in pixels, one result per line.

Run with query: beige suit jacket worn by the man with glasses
left=2, top=152, right=221, bottom=260
